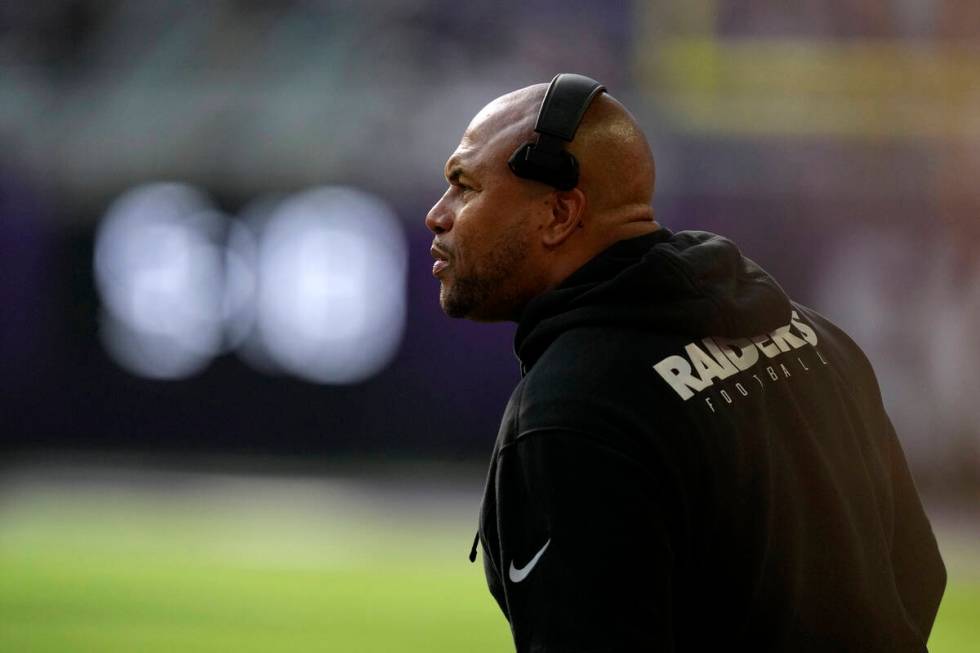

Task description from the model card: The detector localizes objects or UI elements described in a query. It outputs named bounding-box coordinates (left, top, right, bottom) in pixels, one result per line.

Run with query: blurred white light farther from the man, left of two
left=95, top=183, right=225, bottom=379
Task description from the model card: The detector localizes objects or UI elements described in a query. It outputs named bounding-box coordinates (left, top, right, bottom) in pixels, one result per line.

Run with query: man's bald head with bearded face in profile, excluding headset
left=425, top=77, right=659, bottom=321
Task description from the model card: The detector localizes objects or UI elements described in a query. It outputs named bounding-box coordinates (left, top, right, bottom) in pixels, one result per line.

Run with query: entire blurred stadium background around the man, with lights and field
left=0, top=0, right=980, bottom=653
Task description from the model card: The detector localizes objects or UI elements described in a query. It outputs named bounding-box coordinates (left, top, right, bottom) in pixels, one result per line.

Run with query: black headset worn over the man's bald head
left=507, top=73, right=606, bottom=190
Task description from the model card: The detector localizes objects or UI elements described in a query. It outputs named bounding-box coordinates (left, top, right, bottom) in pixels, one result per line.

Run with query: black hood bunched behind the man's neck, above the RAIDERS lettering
left=514, top=228, right=792, bottom=370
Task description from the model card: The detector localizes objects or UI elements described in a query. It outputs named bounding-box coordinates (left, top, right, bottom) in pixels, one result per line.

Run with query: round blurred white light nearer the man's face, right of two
left=252, top=187, right=408, bottom=383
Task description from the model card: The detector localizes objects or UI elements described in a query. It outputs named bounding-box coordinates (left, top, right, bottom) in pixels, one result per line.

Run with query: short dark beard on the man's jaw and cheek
left=439, top=233, right=528, bottom=321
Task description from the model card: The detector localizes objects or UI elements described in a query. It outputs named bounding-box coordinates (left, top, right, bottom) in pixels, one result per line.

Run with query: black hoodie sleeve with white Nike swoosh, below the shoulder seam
left=496, top=429, right=674, bottom=653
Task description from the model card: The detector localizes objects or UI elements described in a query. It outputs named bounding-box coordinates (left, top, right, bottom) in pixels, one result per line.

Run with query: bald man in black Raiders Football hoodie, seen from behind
left=426, top=78, right=945, bottom=652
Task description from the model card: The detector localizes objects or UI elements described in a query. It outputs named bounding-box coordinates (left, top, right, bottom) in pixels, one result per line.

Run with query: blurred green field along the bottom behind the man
left=0, top=466, right=980, bottom=653
